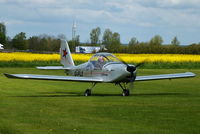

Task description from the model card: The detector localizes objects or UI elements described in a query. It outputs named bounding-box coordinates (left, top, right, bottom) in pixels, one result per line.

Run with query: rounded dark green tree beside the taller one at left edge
left=12, top=32, right=28, bottom=50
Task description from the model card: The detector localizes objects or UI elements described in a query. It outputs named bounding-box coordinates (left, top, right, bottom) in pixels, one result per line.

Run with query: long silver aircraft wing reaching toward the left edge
left=4, top=74, right=103, bottom=82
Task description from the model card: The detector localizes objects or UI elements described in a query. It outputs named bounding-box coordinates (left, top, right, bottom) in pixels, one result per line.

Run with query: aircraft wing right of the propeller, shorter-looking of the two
left=135, top=72, right=196, bottom=81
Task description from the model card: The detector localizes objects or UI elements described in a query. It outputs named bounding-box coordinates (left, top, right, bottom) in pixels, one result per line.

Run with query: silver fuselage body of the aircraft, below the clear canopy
left=65, top=61, right=136, bottom=83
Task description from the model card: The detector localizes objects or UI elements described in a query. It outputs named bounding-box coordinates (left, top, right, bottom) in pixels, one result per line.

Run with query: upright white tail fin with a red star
left=60, top=40, right=74, bottom=67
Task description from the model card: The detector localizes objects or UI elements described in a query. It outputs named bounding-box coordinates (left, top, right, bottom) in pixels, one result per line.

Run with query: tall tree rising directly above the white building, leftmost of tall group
left=90, top=27, right=101, bottom=44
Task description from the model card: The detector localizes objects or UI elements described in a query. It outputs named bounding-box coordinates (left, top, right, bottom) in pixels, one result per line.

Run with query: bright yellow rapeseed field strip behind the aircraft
left=0, top=52, right=200, bottom=63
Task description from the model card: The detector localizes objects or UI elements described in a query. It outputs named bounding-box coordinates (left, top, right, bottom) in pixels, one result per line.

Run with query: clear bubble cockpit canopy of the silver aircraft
left=89, top=53, right=120, bottom=69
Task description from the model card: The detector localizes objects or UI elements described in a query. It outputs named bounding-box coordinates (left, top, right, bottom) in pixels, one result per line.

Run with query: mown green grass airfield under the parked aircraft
left=0, top=67, right=200, bottom=134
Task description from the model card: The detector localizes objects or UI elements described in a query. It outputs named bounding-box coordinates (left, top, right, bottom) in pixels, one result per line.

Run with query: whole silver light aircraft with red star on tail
left=5, top=40, right=195, bottom=96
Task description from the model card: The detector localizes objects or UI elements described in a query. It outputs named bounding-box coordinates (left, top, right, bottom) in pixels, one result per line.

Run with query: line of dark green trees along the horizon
left=0, top=23, right=200, bottom=54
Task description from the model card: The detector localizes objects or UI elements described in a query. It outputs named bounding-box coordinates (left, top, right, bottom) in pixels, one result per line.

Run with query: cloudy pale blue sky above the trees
left=0, top=0, right=200, bottom=45
